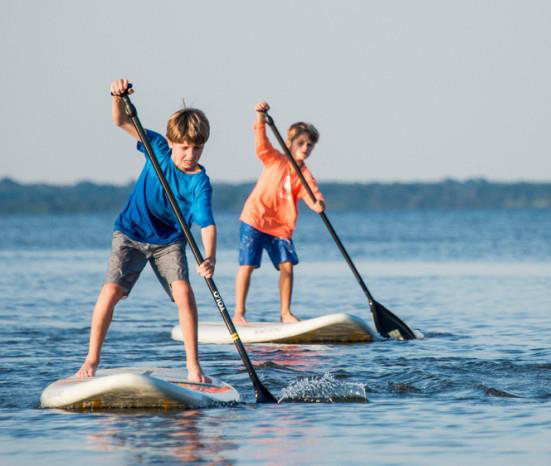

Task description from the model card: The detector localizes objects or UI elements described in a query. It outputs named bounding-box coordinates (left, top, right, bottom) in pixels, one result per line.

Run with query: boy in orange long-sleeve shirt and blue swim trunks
left=233, top=102, right=325, bottom=324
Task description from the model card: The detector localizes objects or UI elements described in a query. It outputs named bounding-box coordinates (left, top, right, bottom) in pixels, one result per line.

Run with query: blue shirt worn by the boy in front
left=115, top=130, right=214, bottom=244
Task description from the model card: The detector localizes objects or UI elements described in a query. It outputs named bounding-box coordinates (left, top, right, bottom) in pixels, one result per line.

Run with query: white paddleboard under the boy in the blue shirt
left=40, top=367, right=239, bottom=410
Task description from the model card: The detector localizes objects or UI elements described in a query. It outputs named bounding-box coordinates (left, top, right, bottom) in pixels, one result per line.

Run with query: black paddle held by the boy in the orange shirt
left=264, top=112, right=416, bottom=340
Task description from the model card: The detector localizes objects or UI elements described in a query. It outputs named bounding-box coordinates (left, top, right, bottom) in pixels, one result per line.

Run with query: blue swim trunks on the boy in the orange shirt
left=239, top=222, right=298, bottom=270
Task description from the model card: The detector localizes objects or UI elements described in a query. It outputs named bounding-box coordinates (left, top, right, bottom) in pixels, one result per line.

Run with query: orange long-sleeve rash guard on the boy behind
left=240, top=122, right=324, bottom=239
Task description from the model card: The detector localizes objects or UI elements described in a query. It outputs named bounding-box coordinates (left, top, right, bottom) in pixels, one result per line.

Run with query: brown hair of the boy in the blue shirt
left=166, top=108, right=210, bottom=144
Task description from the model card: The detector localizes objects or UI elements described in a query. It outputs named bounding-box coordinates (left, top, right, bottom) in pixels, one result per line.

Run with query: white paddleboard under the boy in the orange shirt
left=171, top=313, right=380, bottom=344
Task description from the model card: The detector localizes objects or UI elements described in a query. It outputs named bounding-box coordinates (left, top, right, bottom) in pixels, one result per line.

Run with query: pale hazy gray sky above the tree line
left=0, top=0, right=551, bottom=184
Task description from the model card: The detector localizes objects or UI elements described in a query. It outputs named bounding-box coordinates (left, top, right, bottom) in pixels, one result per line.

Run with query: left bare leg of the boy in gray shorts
left=75, top=283, right=124, bottom=377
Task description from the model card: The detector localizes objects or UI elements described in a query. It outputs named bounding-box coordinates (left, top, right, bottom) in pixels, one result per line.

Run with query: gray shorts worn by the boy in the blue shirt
left=105, top=231, right=189, bottom=301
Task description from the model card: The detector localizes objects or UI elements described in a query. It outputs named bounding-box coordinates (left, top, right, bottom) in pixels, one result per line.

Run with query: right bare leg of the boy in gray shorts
left=171, top=280, right=210, bottom=383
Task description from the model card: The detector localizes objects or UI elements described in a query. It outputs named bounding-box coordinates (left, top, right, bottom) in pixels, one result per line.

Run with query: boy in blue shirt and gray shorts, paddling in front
left=76, top=79, right=216, bottom=382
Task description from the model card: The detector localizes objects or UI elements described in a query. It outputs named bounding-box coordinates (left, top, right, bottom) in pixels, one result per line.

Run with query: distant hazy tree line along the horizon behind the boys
left=0, top=178, right=551, bottom=214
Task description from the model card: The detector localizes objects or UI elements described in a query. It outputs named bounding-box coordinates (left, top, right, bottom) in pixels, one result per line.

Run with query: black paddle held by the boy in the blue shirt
left=121, top=89, right=277, bottom=403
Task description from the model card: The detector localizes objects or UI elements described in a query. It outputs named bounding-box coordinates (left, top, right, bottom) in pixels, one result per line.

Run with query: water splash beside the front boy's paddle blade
left=279, top=372, right=369, bottom=403
